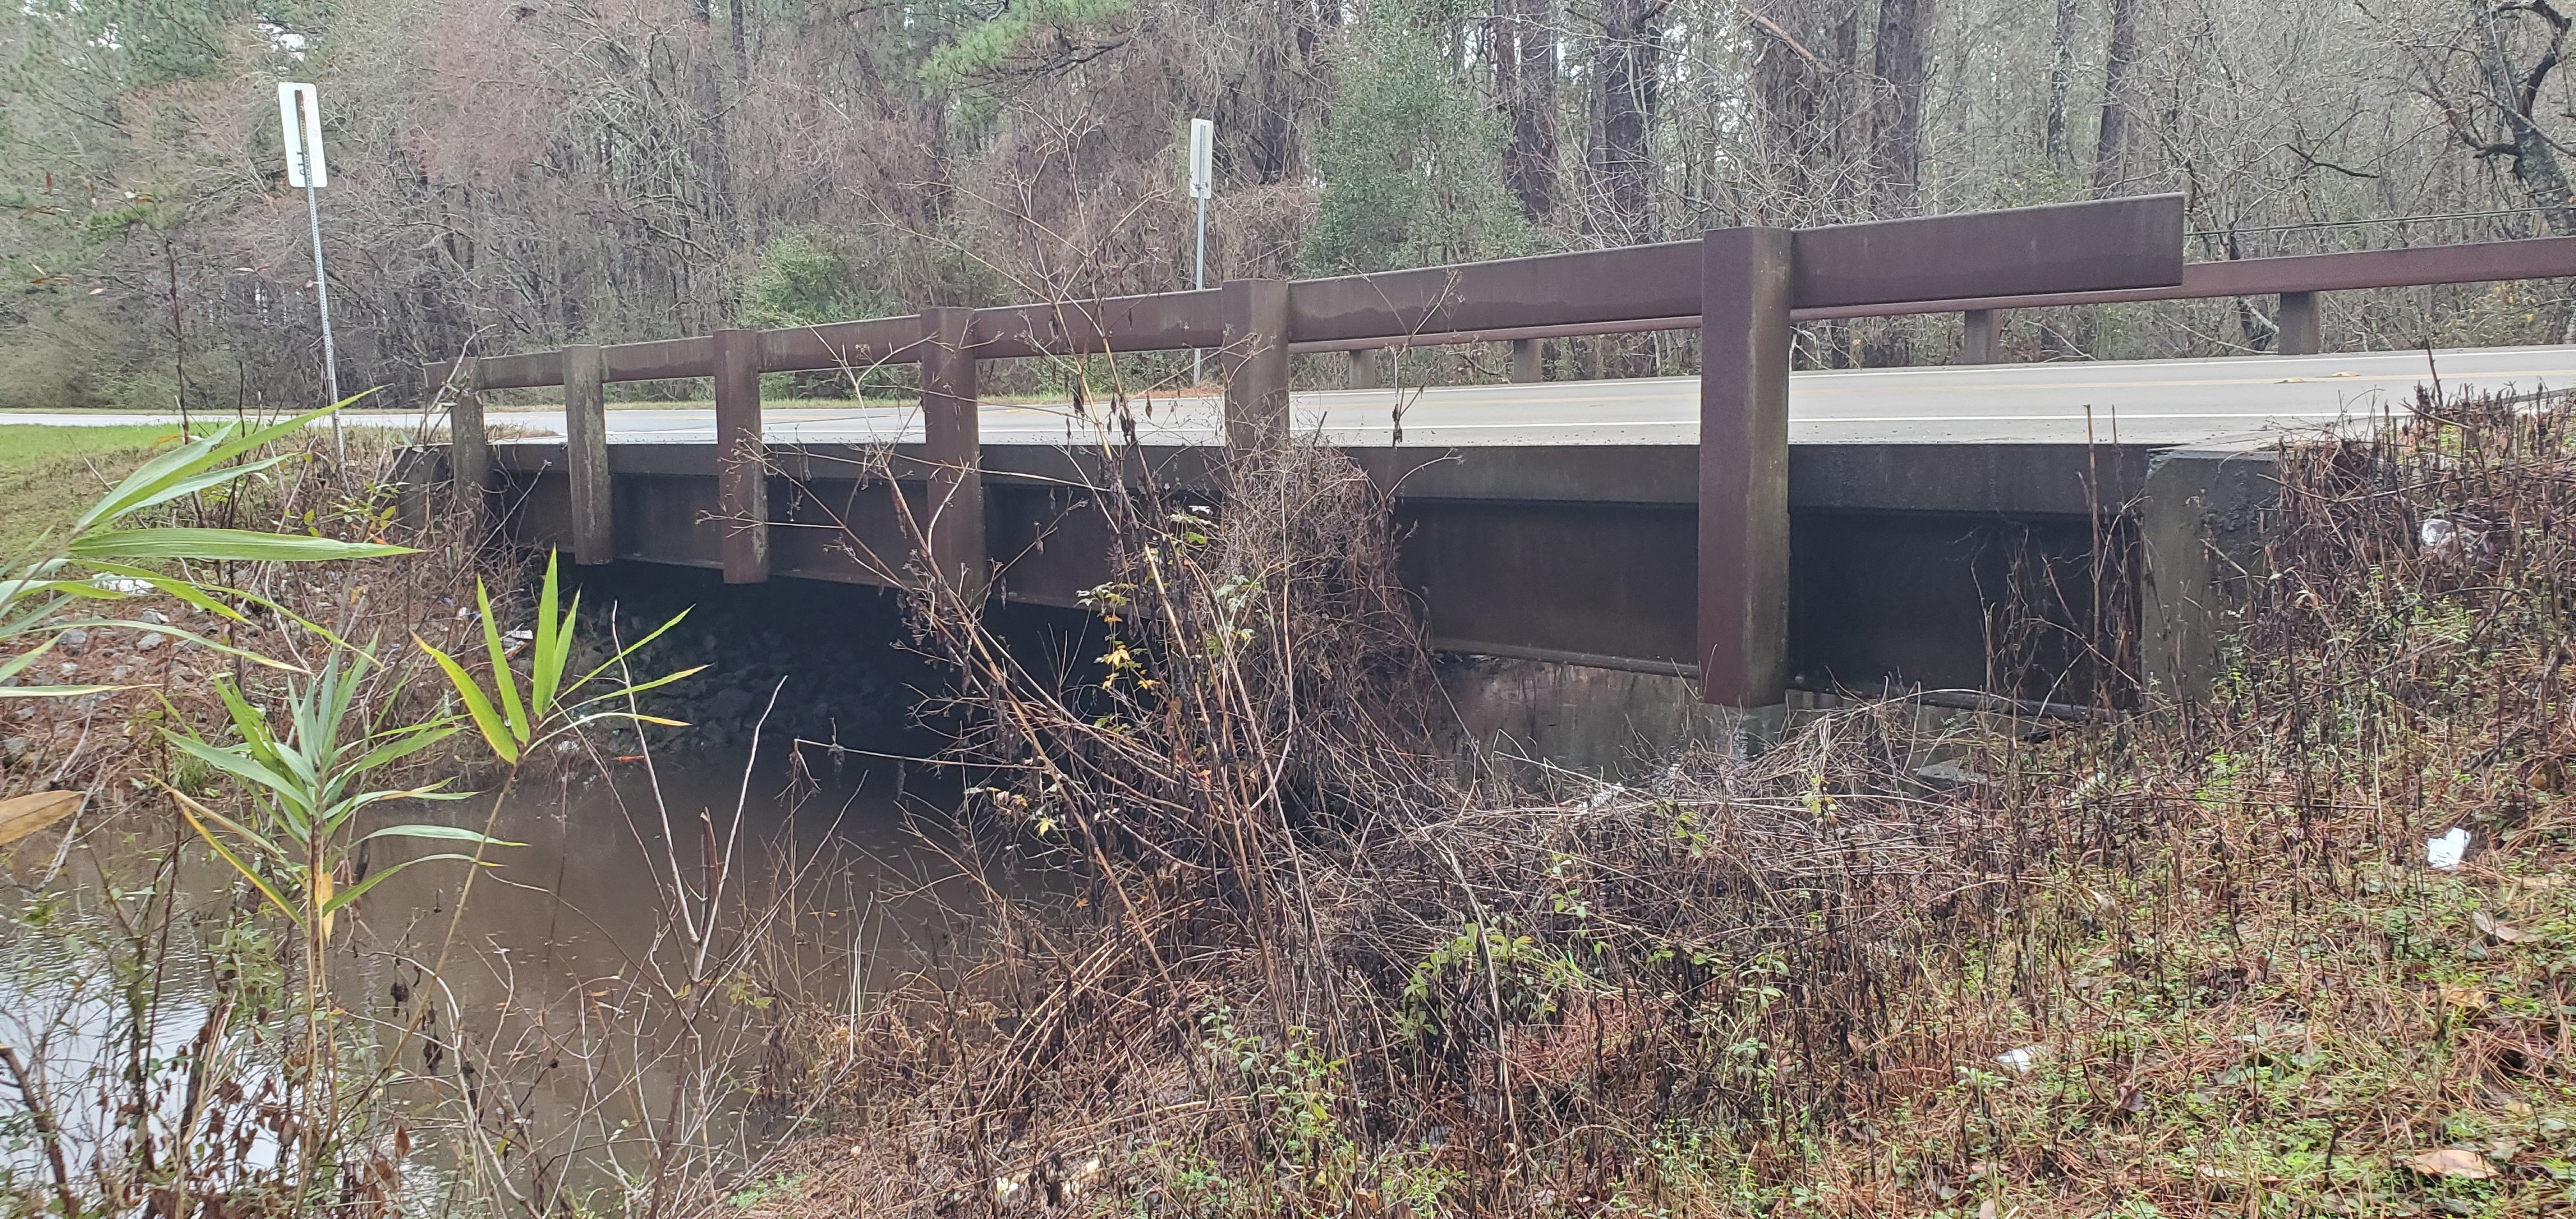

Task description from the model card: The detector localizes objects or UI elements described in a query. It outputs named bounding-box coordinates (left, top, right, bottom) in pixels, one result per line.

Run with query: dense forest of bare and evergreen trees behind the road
left=0, top=0, right=2576, bottom=410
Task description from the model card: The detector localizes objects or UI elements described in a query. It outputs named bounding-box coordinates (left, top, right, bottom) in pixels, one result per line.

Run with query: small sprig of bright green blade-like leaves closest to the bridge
left=412, top=554, right=706, bottom=765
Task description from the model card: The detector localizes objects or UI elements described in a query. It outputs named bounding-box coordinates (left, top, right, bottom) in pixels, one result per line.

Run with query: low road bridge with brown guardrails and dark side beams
left=427, top=196, right=2576, bottom=706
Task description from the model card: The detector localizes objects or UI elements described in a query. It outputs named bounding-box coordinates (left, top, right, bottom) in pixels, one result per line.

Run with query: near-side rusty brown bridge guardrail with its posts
left=427, top=196, right=2235, bottom=706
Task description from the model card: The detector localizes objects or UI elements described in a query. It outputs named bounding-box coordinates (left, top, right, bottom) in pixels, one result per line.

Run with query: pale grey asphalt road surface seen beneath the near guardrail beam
left=15, top=348, right=2576, bottom=448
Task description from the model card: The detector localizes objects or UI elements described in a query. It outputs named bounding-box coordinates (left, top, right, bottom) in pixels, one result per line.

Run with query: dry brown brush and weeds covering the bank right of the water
left=664, top=384, right=2576, bottom=1219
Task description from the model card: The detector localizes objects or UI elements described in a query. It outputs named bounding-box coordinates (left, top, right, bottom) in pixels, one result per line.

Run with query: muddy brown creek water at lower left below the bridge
left=0, top=745, right=1056, bottom=1211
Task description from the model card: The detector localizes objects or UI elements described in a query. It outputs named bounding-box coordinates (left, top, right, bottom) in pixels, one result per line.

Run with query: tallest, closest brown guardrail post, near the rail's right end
left=1698, top=229, right=1793, bottom=706
